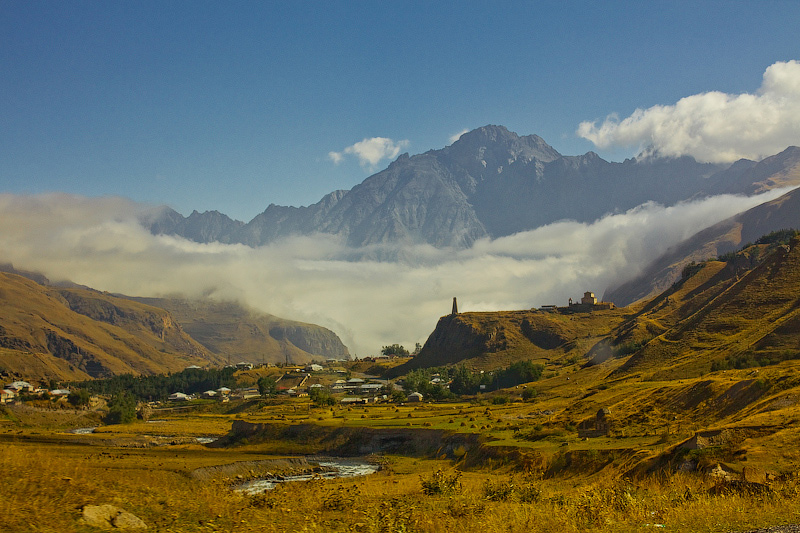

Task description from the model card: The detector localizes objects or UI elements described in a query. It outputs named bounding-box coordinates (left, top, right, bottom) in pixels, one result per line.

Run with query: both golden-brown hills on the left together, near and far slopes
left=0, top=265, right=349, bottom=381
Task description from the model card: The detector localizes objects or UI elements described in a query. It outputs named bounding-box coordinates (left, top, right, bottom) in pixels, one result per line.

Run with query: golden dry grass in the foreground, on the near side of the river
left=0, top=430, right=800, bottom=533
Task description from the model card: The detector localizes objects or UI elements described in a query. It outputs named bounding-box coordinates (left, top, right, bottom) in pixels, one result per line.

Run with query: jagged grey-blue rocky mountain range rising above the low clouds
left=142, top=126, right=800, bottom=248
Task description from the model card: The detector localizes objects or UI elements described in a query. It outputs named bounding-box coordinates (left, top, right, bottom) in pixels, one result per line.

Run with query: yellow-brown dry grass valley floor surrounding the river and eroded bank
left=0, top=368, right=800, bottom=532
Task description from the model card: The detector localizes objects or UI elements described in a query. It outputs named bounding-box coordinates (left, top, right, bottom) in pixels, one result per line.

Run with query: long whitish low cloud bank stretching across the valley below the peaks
left=0, top=191, right=780, bottom=357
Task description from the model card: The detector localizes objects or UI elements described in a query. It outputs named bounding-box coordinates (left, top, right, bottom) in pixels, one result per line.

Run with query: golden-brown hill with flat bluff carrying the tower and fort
left=404, top=235, right=800, bottom=381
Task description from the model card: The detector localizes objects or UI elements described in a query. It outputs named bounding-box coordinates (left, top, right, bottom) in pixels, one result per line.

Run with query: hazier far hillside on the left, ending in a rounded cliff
left=127, top=298, right=350, bottom=364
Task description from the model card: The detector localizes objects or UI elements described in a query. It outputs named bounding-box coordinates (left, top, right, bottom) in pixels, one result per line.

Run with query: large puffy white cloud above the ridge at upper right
left=577, top=60, right=800, bottom=163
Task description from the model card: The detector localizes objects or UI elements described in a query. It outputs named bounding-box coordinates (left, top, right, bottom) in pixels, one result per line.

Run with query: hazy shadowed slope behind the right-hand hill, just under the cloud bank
left=603, top=177, right=800, bottom=305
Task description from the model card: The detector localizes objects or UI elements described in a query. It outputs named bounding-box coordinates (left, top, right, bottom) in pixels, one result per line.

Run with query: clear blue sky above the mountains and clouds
left=0, top=0, right=800, bottom=221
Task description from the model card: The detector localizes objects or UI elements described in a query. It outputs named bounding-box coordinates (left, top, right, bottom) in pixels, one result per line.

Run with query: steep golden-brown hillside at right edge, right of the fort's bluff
left=608, top=235, right=800, bottom=379
